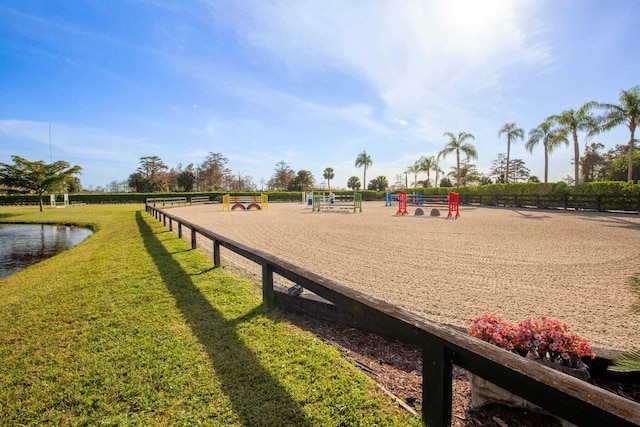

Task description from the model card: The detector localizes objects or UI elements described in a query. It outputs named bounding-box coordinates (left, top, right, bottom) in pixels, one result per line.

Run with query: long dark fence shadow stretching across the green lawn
left=136, top=212, right=309, bottom=426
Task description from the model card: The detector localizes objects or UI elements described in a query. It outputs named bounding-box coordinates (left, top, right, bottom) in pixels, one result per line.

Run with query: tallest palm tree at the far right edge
left=597, top=86, right=640, bottom=181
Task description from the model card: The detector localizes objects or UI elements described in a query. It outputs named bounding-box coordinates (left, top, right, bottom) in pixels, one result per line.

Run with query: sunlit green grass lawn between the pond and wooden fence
left=0, top=205, right=421, bottom=426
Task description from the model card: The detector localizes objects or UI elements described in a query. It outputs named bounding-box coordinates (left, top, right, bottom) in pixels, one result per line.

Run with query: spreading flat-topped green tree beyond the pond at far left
left=0, top=156, right=82, bottom=211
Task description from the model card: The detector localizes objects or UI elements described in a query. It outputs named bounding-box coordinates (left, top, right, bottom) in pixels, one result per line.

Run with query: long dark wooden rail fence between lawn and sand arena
left=146, top=204, right=640, bottom=427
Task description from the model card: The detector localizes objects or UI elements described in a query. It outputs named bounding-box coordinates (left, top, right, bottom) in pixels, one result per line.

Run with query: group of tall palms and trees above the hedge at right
left=398, top=86, right=640, bottom=186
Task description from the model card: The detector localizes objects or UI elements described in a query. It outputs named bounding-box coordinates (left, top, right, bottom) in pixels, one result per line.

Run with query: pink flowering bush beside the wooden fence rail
left=469, top=314, right=596, bottom=367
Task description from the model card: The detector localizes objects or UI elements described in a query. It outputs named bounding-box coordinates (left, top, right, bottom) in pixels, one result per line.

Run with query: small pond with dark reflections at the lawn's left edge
left=0, top=224, right=93, bottom=279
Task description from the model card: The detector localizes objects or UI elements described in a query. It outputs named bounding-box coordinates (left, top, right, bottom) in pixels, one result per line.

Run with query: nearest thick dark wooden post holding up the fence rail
left=422, top=340, right=453, bottom=427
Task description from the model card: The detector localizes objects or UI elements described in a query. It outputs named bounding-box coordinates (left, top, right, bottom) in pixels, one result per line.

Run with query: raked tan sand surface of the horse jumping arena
left=170, top=202, right=640, bottom=350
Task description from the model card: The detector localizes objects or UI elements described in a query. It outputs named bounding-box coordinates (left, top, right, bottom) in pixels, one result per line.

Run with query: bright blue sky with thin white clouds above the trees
left=0, top=0, right=640, bottom=188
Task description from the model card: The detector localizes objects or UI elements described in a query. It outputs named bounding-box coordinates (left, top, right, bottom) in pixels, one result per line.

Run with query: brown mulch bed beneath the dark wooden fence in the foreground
left=287, top=313, right=640, bottom=427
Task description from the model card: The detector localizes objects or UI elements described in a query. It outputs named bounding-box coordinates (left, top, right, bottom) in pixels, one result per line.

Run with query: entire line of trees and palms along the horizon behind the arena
left=0, top=86, right=640, bottom=196
